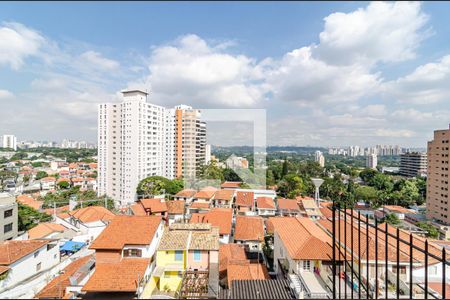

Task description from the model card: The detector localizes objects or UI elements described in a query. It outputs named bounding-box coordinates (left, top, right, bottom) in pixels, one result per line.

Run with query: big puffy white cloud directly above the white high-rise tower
left=141, top=34, right=266, bottom=107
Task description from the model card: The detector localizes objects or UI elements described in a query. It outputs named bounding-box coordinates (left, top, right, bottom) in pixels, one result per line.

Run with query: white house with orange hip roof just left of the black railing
left=270, top=217, right=333, bottom=299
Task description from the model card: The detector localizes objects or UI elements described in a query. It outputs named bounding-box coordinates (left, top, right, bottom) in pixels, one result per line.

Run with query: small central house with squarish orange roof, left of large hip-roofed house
left=234, top=216, right=264, bottom=252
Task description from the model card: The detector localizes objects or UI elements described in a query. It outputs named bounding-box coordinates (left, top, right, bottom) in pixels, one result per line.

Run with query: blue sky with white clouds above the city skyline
left=0, top=2, right=450, bottom=147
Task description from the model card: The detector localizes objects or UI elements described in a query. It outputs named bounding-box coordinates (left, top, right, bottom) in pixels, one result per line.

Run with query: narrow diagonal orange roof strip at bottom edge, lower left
left=35, top=255, right=93, bottom=299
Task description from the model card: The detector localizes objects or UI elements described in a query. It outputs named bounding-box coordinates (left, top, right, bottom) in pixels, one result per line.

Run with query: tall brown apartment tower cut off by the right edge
left=426, top=129, right=450, bottom=224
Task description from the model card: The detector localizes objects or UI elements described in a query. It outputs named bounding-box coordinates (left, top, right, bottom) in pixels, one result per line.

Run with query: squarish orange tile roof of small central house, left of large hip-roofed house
left=234, top=216, right=264, bottom=241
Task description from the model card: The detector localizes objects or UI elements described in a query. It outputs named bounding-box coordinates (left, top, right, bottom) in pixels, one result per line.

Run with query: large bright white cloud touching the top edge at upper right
left=315, top=1, right=430, bottom=65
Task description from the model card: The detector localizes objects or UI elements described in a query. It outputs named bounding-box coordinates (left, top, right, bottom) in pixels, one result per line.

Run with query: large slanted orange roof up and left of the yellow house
left=90, top=216, right=162, bottom=249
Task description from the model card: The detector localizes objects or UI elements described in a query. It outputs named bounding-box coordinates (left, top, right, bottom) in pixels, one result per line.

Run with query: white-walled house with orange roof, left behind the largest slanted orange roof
left=55, top=206, right=115, bottom=243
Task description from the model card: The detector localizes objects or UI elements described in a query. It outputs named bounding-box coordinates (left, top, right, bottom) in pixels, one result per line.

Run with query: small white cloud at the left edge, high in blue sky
left=0, top=23, right=45, bottom=70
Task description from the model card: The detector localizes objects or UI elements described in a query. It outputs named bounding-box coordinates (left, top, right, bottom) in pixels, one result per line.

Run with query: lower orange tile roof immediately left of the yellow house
left=81, top=258, right=149, bottom=292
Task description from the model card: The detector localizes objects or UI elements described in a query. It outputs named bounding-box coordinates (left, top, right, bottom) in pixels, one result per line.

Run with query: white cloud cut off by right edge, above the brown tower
left=383, top=55, right=450, bottom=105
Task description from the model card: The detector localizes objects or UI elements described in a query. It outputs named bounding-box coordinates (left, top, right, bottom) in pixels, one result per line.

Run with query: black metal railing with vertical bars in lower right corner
left=328, top=202, right=450, bottom=299
